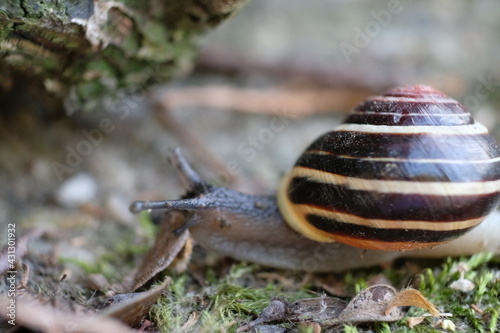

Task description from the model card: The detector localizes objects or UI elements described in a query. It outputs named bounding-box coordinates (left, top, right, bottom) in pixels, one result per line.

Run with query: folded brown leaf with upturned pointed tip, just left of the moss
left=98, top=277, right=170, bottom=327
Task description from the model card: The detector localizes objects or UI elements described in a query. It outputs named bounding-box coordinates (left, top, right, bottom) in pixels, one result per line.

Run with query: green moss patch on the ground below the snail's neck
left=151, top=263, right=312, bottom=332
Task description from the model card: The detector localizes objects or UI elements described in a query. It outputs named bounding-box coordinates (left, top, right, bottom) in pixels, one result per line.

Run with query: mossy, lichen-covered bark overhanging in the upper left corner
left=0, top=0, right=246, bottom=112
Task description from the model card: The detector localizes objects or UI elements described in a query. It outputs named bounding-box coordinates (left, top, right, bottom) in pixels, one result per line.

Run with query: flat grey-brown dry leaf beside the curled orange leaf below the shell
left=320, top=285, right=403, bottom=327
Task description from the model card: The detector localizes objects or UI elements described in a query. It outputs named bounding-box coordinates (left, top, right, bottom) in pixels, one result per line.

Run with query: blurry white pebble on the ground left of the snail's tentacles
left=55, top=173, right=97, bottom=207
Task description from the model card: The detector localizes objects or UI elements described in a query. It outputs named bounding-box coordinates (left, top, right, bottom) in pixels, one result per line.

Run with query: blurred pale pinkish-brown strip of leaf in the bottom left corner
left=0, top=295, right=134, bottom=333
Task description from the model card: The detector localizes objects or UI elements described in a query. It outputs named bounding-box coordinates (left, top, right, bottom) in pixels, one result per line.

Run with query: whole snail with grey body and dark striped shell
left=130, top=85, right=500, bottom=272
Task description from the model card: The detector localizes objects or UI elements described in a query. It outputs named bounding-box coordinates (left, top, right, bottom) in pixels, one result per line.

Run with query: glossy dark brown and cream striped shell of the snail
left=278, top=85, right=500, bottom=250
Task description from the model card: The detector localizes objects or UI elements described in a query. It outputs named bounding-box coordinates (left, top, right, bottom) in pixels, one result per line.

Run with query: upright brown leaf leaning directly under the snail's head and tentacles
left=130, top=212, right=189, bottom=291
